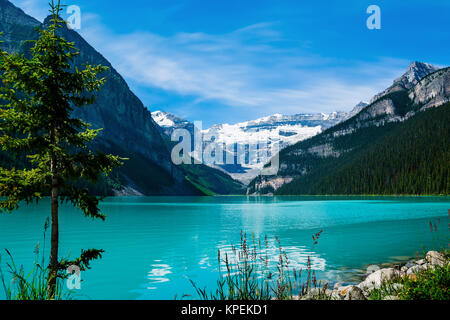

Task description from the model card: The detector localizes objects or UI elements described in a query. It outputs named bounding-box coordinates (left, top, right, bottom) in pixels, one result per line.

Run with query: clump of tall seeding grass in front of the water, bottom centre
left=191, top=233, right=320, bottom=301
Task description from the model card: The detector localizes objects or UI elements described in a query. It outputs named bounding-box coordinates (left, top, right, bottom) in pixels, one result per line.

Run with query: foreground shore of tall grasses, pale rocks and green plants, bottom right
left=188, top=226, right=450, bottom=301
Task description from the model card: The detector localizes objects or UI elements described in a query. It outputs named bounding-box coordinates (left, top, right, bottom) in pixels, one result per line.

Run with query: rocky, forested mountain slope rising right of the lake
left=247, top=62, right=450, bottom=194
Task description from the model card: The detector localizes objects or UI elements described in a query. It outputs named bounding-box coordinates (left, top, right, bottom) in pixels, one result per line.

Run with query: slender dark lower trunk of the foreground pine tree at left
left=47, top=151, right=59, bottom=300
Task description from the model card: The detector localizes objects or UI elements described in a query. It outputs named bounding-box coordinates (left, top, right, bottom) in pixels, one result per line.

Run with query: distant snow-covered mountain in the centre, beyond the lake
left=152, top=108, right=356, bottom=183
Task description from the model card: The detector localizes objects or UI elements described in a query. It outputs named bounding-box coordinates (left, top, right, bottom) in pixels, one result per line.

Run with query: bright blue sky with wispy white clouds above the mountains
left=9, top=0, right=450, bottom=127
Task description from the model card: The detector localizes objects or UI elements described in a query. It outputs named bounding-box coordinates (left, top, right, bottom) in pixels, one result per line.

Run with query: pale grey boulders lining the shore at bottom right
left=298, top=251, right=448, bottom=300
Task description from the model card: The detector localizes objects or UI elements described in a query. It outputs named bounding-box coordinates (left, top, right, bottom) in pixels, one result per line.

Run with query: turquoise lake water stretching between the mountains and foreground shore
left=0, top=197, right=450, bottom=300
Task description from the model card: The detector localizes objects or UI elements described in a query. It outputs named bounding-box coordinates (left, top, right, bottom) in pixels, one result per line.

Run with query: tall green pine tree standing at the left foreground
left=0, top=1, right=124, bottom=299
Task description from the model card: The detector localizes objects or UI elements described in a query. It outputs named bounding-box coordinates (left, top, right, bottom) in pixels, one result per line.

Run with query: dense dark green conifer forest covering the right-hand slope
left=277, top=103, right=450, bottom=195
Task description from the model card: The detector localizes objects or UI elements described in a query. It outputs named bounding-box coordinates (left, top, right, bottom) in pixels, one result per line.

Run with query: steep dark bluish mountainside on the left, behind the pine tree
left=0, top=0, right=197, bottom=194
